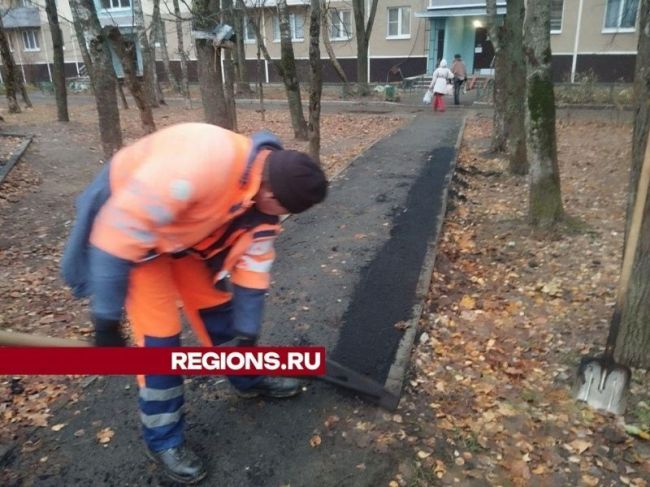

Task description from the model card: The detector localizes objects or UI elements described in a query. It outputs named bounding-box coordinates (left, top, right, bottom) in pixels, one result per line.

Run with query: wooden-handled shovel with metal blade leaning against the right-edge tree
left=574, top=133, right=650, bottom=414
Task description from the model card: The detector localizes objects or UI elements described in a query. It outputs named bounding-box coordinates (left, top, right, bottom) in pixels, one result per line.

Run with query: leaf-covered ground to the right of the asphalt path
left=352, top=115, right=650, bottom=487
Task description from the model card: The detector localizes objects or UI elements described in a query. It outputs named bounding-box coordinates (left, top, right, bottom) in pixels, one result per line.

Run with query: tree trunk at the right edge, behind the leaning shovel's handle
left=615, top=0, right=650, bottom=370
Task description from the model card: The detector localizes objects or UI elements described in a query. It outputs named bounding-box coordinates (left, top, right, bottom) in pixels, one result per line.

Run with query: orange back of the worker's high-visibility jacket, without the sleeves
left=90, top=123, right=265, bottom=262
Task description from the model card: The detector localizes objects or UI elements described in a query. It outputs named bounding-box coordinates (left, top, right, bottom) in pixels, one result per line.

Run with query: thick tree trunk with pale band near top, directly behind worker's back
left=192, top=0, right=232, bottom=129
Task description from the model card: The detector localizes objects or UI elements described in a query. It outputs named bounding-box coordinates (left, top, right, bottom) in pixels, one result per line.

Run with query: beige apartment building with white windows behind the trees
left=2, top=0, right=639, bottom=83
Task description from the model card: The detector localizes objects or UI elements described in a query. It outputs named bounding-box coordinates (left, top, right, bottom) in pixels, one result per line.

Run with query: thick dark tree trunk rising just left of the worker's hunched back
left=70, top=0, right=122, bottom=159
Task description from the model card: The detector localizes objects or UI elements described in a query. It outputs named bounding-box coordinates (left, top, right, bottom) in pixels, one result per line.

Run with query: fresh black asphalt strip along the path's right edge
left=332, top=146, right=455, bottom=383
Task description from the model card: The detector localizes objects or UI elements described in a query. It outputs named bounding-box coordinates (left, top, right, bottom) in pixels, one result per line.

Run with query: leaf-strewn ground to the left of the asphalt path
left=0, top=100, right=408, bottom=450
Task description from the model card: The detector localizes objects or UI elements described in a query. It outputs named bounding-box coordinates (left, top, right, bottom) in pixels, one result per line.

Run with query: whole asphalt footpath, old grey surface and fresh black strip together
left=6, top=111, right=462, bottom=487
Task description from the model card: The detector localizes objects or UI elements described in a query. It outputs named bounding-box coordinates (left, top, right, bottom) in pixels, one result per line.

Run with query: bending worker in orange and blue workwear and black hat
left=62, top=123, right=327, bottom=483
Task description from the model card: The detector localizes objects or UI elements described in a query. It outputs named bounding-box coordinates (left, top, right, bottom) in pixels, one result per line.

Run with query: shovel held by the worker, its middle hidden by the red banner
left=0, top=330, right=399, bottom=411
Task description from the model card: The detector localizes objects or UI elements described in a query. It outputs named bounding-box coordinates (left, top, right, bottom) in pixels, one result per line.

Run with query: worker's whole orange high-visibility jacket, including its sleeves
left=66, top=123, right=281, bottom=328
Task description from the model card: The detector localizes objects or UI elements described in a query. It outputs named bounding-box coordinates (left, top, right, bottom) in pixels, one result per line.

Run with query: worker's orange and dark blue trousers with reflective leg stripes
left=126, top=255, right=261, bottom=451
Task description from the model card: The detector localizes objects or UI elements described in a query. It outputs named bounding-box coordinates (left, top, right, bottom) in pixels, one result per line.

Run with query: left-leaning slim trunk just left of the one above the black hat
left=277, top=0, right=308, bottom=140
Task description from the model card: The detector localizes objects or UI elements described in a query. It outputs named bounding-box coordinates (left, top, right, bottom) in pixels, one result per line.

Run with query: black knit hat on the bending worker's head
left=266, top=150, right=327, bottom=213
